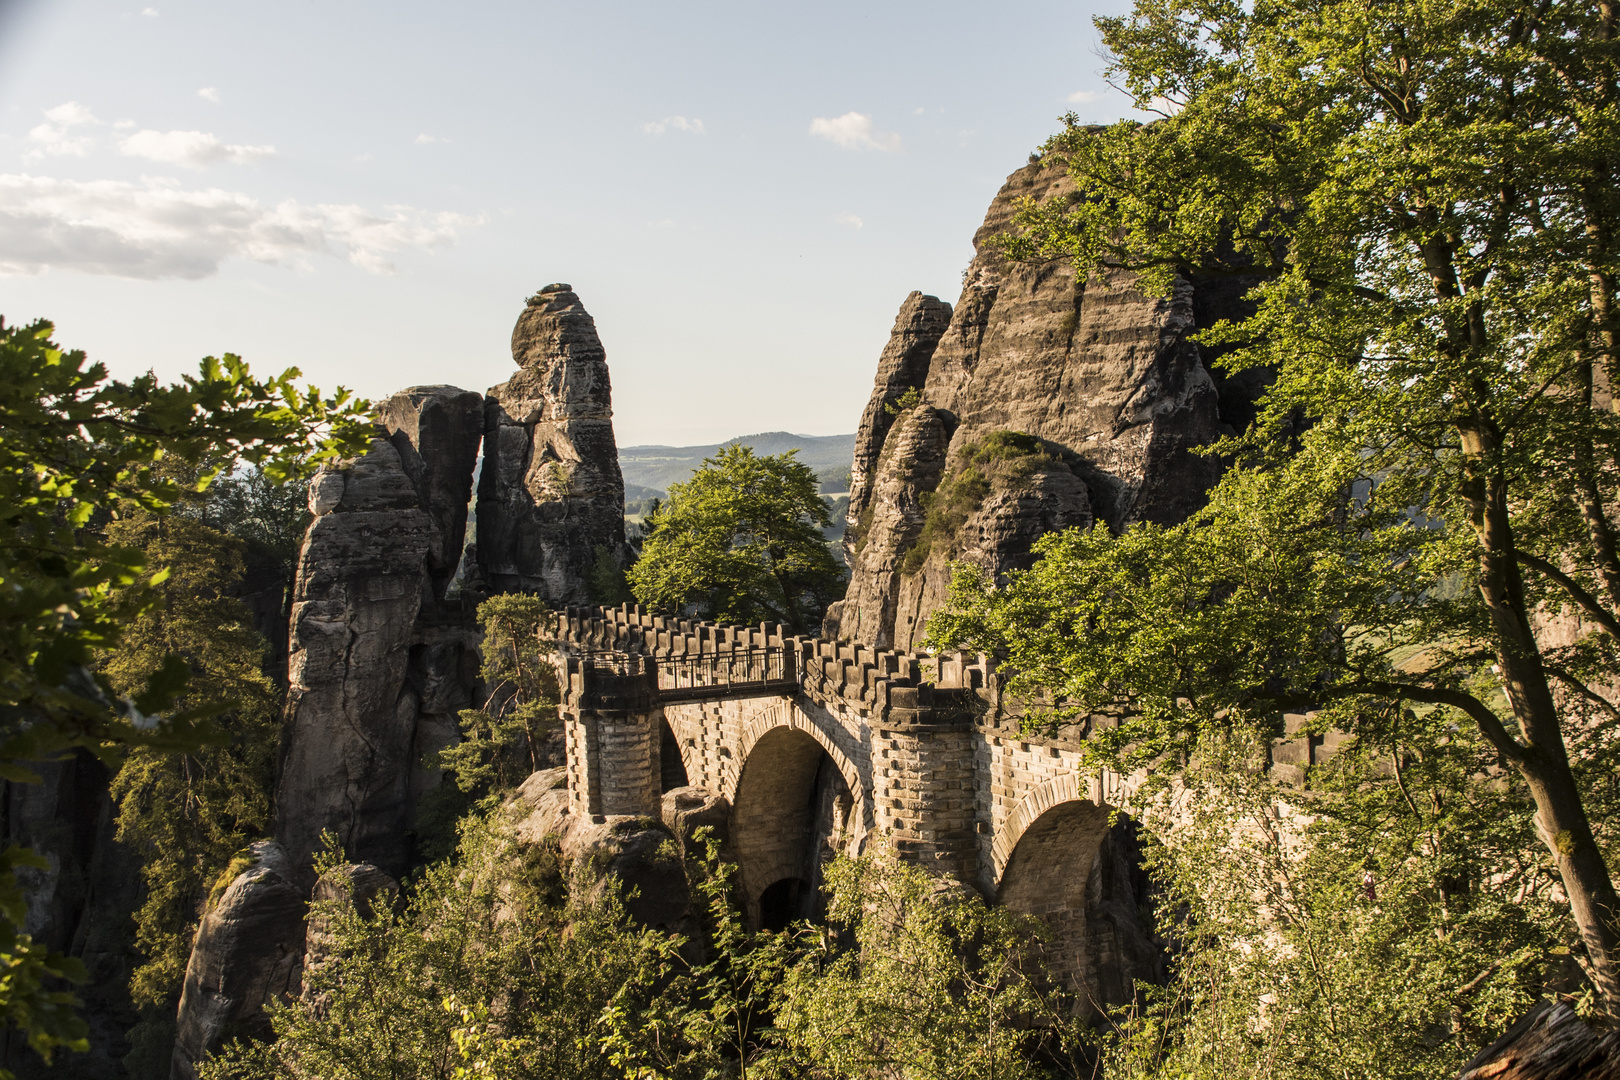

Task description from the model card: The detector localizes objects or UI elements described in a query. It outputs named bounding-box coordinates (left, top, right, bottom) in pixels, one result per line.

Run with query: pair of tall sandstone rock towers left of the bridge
left=277, top=285, right=625, bottom=886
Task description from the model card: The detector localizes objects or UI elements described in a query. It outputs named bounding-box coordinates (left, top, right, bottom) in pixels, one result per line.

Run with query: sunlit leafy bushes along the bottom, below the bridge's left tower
left=201, top=818, right=791, bottom=1080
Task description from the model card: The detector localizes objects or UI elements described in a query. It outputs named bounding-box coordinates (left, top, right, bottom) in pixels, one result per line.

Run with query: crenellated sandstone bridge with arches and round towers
left=557, top=606, right=1165, bottom=1004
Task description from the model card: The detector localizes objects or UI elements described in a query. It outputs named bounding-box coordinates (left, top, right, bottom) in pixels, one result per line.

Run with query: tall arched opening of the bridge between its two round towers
left=731, top=727, right=855, bottom=929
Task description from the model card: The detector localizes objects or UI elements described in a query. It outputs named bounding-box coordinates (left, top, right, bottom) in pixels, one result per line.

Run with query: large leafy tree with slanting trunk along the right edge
left=932, top=0, right=1620, bottom=1012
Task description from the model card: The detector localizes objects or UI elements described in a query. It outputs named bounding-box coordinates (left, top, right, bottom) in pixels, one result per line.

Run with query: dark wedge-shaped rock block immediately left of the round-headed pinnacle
left=377, top=385, right=484, bottom=599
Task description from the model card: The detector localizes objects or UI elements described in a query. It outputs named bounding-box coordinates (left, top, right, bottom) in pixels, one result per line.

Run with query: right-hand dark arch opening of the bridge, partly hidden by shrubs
left=996, top=801, right=1168, bottom=1014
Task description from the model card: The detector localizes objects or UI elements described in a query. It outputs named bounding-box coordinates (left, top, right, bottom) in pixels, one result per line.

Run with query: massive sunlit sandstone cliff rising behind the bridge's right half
left=826, top=164, right=1260, bottom=649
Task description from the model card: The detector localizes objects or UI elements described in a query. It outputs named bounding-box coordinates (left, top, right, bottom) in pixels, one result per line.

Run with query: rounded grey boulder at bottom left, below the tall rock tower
left=170, top=840, right=305, bottom=1080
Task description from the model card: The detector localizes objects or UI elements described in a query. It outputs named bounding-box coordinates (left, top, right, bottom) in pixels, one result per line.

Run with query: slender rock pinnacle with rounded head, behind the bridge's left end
left=478, top=285, right=627, bottom=604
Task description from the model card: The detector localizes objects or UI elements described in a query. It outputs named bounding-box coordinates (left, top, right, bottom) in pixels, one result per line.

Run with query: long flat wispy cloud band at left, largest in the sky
left=0, top=175, right=483, bottom=280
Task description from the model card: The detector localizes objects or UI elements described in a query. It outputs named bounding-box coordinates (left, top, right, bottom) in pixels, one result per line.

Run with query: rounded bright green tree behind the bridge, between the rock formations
left=629, top=445, right=842, bottom=630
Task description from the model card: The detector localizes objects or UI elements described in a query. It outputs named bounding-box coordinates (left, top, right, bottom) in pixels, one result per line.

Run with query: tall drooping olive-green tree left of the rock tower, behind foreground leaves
left=99, top=510, right=280, bottom=1006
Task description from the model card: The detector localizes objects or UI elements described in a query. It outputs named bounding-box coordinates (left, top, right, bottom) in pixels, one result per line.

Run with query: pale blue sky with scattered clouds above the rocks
left=0, top=0, right=1129, bottom=445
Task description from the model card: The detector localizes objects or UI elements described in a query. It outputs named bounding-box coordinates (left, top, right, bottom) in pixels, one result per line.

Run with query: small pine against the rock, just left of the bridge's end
left=439, top=593, right=562, bottom=797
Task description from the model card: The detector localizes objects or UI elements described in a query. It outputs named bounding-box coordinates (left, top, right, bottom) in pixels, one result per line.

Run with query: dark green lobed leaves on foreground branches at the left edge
left=0, top=314, right=366, bottom=1059
